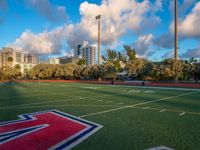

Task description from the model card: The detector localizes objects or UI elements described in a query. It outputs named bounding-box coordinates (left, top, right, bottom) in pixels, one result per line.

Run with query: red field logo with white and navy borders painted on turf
left=0, top=110, right=101, bottom=150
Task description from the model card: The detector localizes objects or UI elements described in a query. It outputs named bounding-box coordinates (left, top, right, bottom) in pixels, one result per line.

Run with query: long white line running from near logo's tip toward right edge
left=79, top=92, right=198, bottom=118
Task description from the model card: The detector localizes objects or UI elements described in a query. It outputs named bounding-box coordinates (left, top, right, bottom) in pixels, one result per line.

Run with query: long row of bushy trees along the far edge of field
left=0, top=46, right=200, bottom=81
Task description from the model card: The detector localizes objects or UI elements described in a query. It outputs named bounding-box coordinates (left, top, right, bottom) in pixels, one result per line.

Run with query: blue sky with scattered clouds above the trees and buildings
left=0, top=0, right=200, bottom=61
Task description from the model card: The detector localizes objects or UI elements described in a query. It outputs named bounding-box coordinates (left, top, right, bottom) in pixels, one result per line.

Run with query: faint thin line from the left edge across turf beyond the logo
left=0, top=95, right=110, bottom=109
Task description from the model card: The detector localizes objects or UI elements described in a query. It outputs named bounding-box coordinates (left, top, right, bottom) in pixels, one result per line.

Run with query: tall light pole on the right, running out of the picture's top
left=174, top=0, right=179, bottom=60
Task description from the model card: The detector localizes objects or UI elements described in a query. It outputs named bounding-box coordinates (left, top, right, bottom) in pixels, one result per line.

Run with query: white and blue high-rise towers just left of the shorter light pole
left=74, top=41, right=96, bottom=66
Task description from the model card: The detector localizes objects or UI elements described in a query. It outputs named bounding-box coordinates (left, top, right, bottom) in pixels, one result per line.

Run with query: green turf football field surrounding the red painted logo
left=0, top=83, right=200, bottom=150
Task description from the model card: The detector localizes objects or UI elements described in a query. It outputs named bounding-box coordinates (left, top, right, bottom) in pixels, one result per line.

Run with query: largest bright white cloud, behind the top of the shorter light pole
left=69, top=0, right=162, bottom=46
